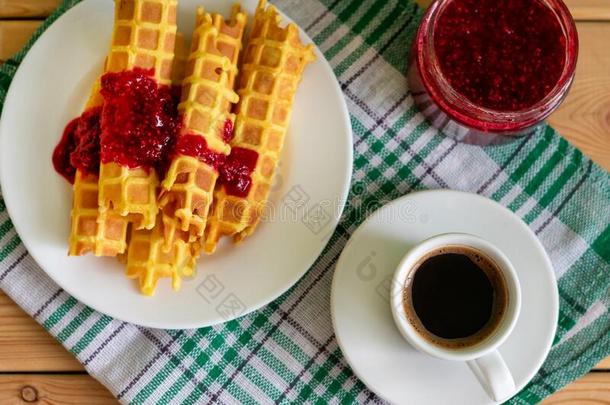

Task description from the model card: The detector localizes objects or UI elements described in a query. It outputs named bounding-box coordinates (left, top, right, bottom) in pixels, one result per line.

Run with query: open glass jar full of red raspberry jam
left=408, top=0, right=578, bottom=144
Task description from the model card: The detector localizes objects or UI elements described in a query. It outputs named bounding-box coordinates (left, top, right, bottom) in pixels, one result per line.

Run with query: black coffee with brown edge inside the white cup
left=404, top=246, right=508, bottom=347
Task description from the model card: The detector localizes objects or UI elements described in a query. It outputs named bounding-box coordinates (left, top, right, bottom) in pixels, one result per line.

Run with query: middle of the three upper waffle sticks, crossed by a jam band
left=159, top=6, right=246, bottom=241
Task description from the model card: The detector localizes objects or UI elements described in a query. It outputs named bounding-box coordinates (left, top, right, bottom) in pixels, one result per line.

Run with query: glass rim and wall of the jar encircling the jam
left=413, top=0, right=578, bottom=132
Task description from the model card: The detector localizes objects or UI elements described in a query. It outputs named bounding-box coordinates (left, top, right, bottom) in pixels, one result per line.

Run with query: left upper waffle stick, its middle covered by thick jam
left=98, top=0, right=176, bottom=229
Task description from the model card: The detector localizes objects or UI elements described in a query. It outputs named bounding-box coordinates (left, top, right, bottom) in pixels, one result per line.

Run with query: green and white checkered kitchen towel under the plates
left=0, top=0, right=610, bottom=403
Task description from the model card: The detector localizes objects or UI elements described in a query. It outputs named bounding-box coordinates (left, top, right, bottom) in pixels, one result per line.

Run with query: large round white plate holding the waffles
left=0, top=0, right=352, bottom=329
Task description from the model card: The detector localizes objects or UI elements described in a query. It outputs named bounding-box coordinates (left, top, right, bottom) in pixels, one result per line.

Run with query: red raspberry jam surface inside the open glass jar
left=434, top=0, right=566, bottom=111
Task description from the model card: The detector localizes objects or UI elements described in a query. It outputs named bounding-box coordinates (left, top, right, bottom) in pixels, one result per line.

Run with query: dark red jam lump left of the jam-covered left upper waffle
left=53, top=107, right=102, bottom=183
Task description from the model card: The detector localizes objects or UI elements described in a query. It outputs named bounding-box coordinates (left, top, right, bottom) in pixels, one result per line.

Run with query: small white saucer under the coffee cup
left=331, top=190, right=559, bottom=405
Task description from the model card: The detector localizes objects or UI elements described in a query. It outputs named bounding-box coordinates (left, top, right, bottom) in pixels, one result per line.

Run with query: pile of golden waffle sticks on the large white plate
left=64, top=0, right=314, bottom=295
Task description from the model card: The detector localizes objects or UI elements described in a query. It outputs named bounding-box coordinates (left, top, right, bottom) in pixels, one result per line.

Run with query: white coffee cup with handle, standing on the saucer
left=390, top=233, right=521, bottom=401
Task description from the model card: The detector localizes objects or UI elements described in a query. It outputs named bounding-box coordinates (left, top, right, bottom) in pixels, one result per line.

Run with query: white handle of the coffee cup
left=466, top=350, right=515, bottom=401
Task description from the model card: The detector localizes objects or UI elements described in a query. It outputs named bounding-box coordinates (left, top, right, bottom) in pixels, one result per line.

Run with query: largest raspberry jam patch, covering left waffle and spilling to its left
left=52, top=69, right=181, bottom=183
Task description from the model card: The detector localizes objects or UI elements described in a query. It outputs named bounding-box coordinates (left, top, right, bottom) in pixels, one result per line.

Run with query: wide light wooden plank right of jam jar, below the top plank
left=549, top=22, right=610, bottom=170
